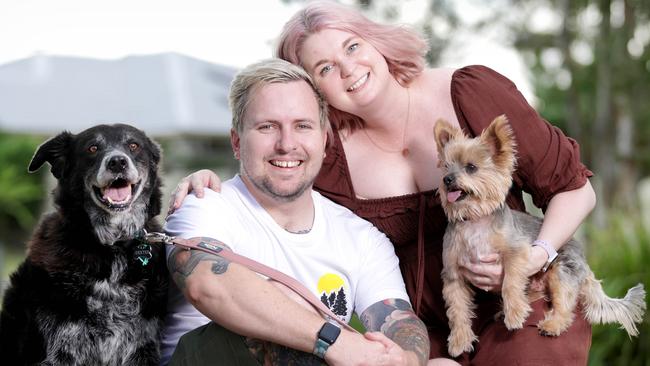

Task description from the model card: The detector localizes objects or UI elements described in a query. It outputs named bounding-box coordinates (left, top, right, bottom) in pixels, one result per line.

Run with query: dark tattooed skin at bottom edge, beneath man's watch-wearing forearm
left=244, top=338, right=326, bottom=366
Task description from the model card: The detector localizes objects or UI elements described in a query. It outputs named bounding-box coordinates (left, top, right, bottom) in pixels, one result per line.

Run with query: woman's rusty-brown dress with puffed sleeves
left=315, top=66, right=592, bottom=366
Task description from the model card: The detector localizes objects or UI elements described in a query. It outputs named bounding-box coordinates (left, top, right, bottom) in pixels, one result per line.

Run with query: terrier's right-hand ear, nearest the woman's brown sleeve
left=480, top=114, right=517, bottom=170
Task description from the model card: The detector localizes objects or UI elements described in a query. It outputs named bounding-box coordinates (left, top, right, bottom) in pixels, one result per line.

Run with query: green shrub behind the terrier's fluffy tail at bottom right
left=587, top=214, right=650, bottom=366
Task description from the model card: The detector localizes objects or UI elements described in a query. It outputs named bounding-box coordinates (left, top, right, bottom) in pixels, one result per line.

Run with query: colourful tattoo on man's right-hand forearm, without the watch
left=361, top=299, right=430, bottom=365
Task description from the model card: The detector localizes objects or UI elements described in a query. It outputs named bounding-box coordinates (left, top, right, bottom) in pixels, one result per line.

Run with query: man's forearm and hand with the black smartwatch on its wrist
left=168, top=243, right=385, bottom=365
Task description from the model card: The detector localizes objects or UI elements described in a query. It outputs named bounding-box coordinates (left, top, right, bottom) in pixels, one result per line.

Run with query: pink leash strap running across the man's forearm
left=144, top=232, right=358, bottom=333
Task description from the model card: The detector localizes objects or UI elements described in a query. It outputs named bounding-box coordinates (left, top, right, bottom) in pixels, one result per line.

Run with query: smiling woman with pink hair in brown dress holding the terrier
left=171, top=2, right=595, bottom=365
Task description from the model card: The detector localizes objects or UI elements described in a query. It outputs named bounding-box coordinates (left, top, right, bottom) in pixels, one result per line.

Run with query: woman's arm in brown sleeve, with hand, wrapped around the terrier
left=452, top=66, right=595, bottom=290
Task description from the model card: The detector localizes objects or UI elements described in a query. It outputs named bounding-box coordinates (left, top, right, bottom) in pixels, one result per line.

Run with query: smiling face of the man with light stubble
left=231, top=80, right=327, bottom=201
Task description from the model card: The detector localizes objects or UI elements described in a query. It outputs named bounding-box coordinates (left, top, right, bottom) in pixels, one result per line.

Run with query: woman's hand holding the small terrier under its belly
left=460, top=253, right=503, bottom=292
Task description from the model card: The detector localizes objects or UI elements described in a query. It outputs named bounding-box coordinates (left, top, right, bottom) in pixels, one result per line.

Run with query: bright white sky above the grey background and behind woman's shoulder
left=0, top=0, right=534, bottom=101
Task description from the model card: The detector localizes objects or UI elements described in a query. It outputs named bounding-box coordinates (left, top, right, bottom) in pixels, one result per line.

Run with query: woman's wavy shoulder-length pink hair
left=276, top=1, right=428, bottom=130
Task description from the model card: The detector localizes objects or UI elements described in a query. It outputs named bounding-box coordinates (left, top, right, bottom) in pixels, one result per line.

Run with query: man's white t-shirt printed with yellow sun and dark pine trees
left=162, top=176, right=408, bottom=364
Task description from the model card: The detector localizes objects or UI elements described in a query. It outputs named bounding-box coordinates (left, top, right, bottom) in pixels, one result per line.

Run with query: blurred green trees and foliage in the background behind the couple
left=0, top=0, right=650, bottom=366
